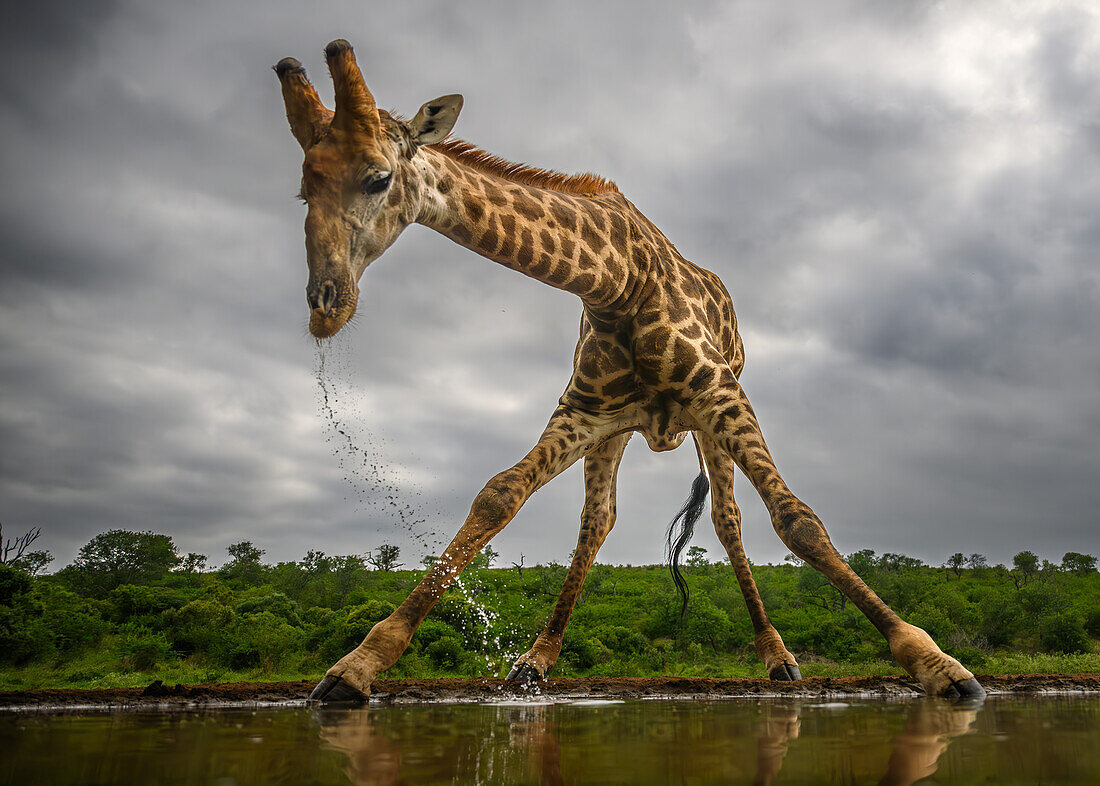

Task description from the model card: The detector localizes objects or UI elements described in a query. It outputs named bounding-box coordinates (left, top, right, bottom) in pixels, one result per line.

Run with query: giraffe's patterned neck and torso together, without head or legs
left=415, top=144, right=744, bottom=451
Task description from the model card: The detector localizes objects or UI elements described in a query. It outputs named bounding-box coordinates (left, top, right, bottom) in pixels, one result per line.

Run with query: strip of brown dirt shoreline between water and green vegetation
left=0, top=674, right=1100, bottom=712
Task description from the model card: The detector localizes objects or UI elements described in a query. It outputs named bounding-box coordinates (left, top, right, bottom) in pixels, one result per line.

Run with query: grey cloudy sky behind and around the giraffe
left=0, top=0, right=1100, bottom=569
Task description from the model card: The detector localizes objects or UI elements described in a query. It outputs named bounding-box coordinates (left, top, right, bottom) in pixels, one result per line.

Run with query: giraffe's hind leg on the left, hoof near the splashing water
left=508, top=433, right=630, bottom=683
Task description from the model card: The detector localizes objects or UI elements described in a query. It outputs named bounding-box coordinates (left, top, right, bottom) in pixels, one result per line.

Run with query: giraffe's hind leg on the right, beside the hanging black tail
left=695, top=432, right=802, bottom=679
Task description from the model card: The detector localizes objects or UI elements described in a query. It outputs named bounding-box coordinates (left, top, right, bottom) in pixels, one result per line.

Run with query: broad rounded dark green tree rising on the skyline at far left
left=66, top=530, right=179, bottom=595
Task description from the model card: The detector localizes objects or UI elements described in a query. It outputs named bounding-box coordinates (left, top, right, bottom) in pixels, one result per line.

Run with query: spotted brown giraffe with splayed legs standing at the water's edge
left=274, top=38, right=985, bottom=701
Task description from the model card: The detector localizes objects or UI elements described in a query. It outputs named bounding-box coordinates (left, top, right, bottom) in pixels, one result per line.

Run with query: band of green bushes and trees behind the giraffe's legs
left=0, top=530, right=1100, bottom=689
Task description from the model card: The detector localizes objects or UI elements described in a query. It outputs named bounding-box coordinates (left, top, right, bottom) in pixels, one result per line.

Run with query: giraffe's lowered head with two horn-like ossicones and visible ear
left=275, top=40, right=462, bottom=339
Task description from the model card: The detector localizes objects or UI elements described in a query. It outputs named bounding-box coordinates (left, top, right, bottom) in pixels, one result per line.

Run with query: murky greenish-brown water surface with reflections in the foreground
left=0, top=697, right=1100, bottom=786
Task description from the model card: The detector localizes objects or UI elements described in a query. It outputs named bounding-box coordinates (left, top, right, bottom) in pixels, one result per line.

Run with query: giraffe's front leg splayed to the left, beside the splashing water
left=309, top=407, right=603, bottom=701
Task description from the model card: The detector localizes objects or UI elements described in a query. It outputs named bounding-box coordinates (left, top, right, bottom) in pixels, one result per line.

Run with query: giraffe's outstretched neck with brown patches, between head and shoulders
left=417, top=148, right=651, bottom=313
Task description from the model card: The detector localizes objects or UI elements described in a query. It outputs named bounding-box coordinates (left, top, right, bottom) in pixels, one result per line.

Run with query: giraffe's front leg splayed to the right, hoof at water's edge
left=692, top=366, right=986, bottom=696
